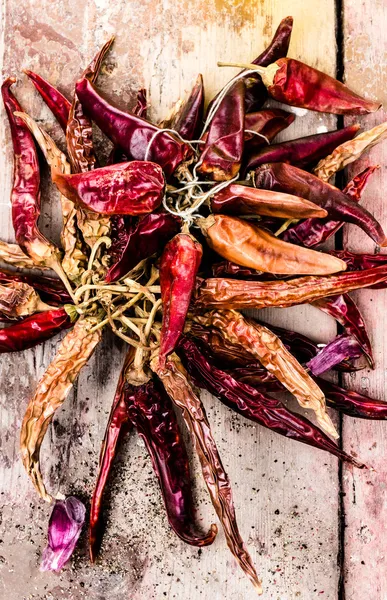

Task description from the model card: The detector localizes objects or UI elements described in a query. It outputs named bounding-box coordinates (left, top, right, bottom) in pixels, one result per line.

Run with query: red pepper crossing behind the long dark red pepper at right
left=281, top=166, right=379, bottom=248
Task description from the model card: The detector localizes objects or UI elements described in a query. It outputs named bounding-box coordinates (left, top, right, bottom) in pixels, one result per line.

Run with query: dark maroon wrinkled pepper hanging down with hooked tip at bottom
left=124, top=381, right=217, bottom=547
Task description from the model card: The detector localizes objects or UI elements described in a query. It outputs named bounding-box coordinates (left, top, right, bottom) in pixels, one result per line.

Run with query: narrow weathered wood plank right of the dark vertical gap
left=343, top=1, right=387, bottom=600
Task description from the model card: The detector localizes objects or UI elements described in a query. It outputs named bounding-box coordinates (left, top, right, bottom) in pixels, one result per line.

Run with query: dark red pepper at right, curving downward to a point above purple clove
left=311, top=294, right=375, bottom=368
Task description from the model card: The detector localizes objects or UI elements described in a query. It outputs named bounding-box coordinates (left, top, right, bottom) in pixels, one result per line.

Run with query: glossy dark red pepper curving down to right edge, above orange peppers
left=255, top=163, right=387, bottom=246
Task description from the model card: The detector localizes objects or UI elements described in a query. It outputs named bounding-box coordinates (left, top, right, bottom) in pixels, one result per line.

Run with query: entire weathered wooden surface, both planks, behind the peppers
left=0, top=0, right=387, bottom=600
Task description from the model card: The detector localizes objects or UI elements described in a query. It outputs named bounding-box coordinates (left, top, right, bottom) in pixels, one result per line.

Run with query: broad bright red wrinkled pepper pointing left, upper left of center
left=52, top=161, right=165, bottom=216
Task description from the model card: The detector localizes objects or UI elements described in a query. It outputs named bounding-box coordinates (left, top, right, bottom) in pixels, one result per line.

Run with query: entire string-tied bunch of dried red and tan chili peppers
left=0, top=17, right=387, bottom=593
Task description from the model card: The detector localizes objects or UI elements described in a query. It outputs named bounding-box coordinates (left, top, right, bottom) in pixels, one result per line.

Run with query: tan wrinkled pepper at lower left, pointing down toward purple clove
left=20, top=318, right=102, bottom=502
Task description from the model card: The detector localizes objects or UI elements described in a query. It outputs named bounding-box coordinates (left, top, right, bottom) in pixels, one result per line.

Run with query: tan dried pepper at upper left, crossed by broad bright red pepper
left=15, top=113, right=87, bottom=281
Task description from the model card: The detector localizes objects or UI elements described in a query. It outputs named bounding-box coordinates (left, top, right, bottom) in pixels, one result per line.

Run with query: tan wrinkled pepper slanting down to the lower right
left=194, top=310, right=339, bottom=438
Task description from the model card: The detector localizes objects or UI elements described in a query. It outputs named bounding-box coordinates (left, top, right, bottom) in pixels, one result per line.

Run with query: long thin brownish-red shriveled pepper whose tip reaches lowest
left=151, top=354, right=262, bottom=594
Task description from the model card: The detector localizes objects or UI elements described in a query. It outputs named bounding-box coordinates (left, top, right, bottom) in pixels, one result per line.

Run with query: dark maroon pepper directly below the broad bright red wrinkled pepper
left=105, top=213, right=181, bottom=283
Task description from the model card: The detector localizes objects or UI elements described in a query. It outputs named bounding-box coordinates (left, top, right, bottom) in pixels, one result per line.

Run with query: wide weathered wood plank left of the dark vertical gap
left=0, top=0, right=338, bottom=600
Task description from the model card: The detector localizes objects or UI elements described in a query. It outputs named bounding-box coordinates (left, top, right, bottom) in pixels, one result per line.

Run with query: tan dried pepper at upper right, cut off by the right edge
left=313, top=122, right=387, bottom=181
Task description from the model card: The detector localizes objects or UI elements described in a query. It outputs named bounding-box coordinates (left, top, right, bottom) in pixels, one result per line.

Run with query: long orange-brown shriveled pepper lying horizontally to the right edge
left=194, top=265, right=387, bottom=309
